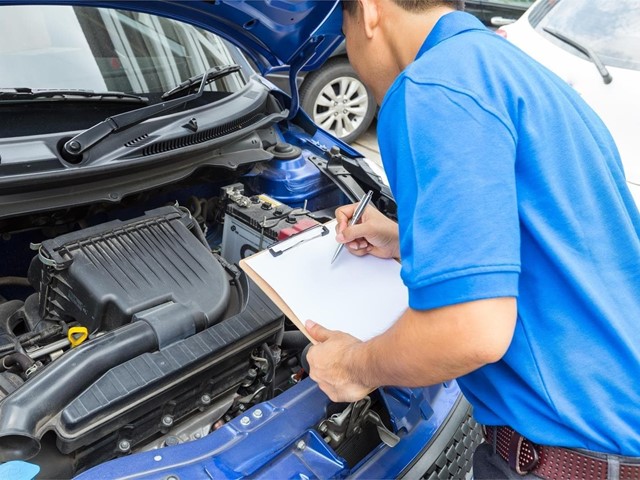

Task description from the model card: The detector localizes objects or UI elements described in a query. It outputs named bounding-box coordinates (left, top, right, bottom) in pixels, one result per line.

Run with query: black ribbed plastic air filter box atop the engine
left=29, top=207, right=230, bottom=332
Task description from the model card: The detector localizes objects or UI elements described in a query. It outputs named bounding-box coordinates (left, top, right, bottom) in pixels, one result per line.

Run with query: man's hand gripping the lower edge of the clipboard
left=305, top=320, right=375, bottom=402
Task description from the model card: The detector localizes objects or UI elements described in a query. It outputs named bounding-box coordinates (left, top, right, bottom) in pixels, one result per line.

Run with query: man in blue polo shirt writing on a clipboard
left=308, top=0, right=640, bottom=478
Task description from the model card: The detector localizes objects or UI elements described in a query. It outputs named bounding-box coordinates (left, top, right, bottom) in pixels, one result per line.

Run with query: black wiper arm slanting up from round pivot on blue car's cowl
left=63, top=65, right=240, bottom=158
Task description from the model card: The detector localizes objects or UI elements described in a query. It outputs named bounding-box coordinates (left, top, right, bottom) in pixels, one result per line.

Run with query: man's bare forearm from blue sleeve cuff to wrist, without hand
left=350, top=298, right=516, bottom=387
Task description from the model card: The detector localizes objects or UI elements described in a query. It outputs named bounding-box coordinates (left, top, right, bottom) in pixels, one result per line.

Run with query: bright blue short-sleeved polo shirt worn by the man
left=378, top=12, right=640, bottom=456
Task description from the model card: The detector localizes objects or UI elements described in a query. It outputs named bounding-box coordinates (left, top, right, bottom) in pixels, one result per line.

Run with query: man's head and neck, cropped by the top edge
left=342, top=0, right=464, bottom=103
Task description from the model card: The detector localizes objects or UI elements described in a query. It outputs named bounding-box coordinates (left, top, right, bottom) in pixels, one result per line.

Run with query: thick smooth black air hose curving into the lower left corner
left=0, top=321, right=158, bottom=462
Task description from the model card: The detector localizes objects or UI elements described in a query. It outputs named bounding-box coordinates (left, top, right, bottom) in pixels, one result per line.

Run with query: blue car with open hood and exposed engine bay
left=0, top=0, right=481, bottom=480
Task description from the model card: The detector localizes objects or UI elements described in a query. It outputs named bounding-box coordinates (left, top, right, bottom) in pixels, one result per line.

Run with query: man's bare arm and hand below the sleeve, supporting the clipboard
left=307, top=297, right=517, bottom=402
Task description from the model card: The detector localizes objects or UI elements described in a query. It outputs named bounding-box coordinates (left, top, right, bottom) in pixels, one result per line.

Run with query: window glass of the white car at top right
left=529, top=0, right=640, bottom=70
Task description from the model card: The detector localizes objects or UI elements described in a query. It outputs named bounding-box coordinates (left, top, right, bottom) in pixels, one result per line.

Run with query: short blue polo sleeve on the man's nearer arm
left=378, top=78, right=520, bottom=310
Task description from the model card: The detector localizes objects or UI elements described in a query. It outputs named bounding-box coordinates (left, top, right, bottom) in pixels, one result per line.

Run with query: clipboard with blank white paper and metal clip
left=239, top=220, right=408, bottom=343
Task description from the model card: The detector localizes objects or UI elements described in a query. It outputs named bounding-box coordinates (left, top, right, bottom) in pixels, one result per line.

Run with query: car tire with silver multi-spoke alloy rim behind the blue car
left=300, top=58, right=377, bottom=143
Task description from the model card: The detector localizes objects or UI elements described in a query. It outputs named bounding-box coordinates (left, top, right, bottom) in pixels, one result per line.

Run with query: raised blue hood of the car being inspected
left=0, top=0, right=342, bottom=74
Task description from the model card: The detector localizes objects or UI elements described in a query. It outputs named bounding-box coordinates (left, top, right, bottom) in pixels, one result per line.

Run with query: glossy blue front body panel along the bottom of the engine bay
left=76, top=379, right=460, bottom=480
